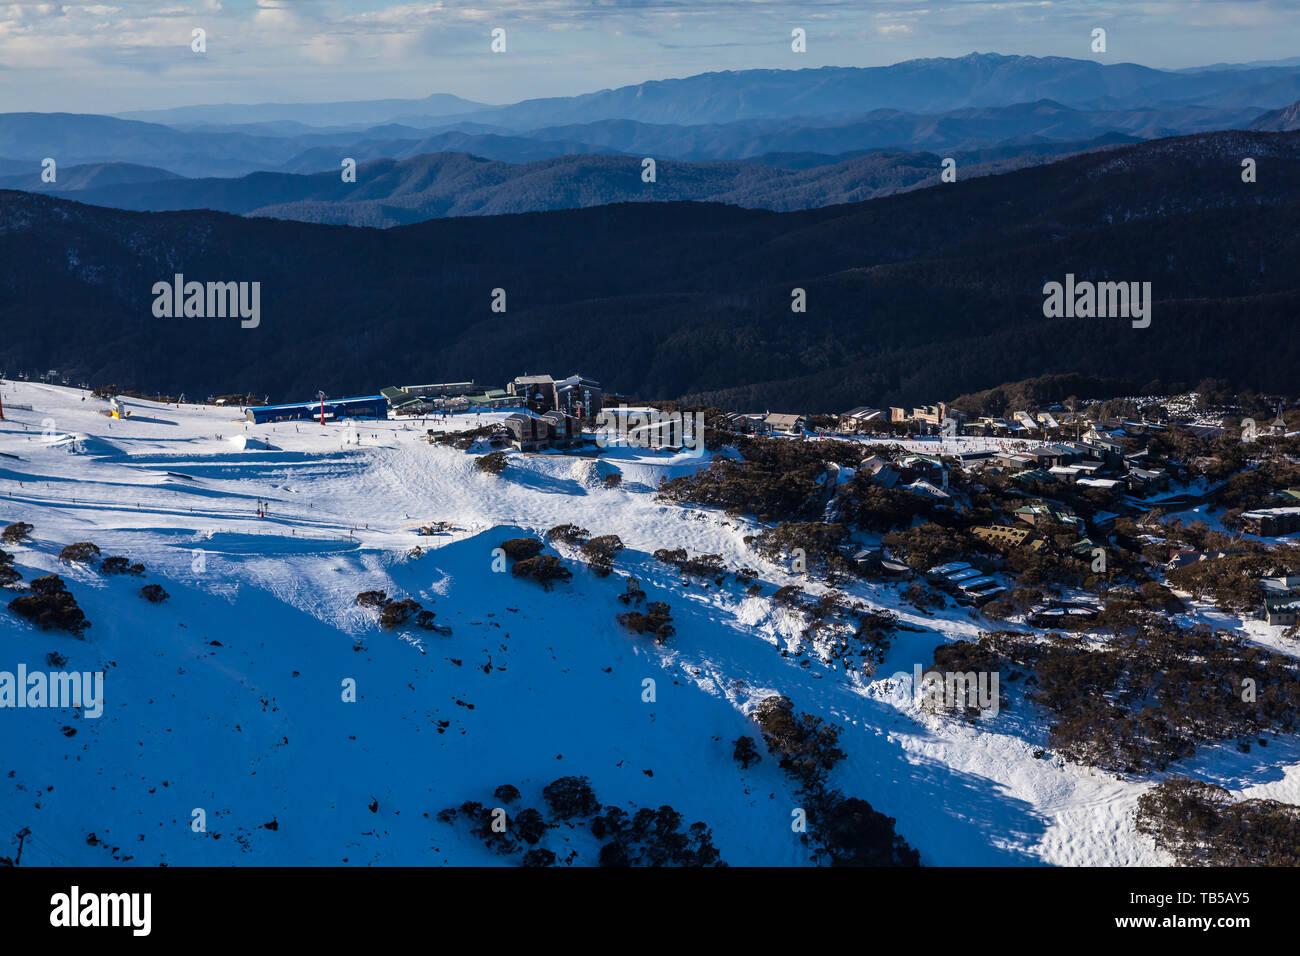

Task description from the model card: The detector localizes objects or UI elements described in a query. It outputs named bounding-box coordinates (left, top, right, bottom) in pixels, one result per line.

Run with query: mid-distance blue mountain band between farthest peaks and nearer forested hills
left=0, top=100, right=1264, bottom=185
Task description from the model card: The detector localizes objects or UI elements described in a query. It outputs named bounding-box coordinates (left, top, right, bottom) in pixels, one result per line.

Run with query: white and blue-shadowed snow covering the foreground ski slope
left=0, top=382, right=1300, bottom=865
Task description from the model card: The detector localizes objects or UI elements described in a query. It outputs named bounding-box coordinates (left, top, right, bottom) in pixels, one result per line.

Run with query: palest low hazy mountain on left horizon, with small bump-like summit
left=118, top=92, right=484, bottom=126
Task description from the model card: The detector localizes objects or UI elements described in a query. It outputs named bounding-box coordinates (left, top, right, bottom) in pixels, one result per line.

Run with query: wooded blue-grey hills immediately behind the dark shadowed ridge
left=0, top=139, right=1117, bottom=228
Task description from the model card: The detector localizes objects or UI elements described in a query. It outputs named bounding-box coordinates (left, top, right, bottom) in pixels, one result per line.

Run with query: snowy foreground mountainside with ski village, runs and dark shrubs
left=0, top=373, right=1300, bottom=866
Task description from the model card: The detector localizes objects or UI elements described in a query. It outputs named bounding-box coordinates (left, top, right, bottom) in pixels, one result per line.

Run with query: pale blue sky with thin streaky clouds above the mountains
left=0, top=0, right=1300, bottom=113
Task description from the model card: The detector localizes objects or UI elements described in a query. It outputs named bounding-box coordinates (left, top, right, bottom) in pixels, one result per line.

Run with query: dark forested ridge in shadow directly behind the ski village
left=0, top=131, right=1300, bottom=411
